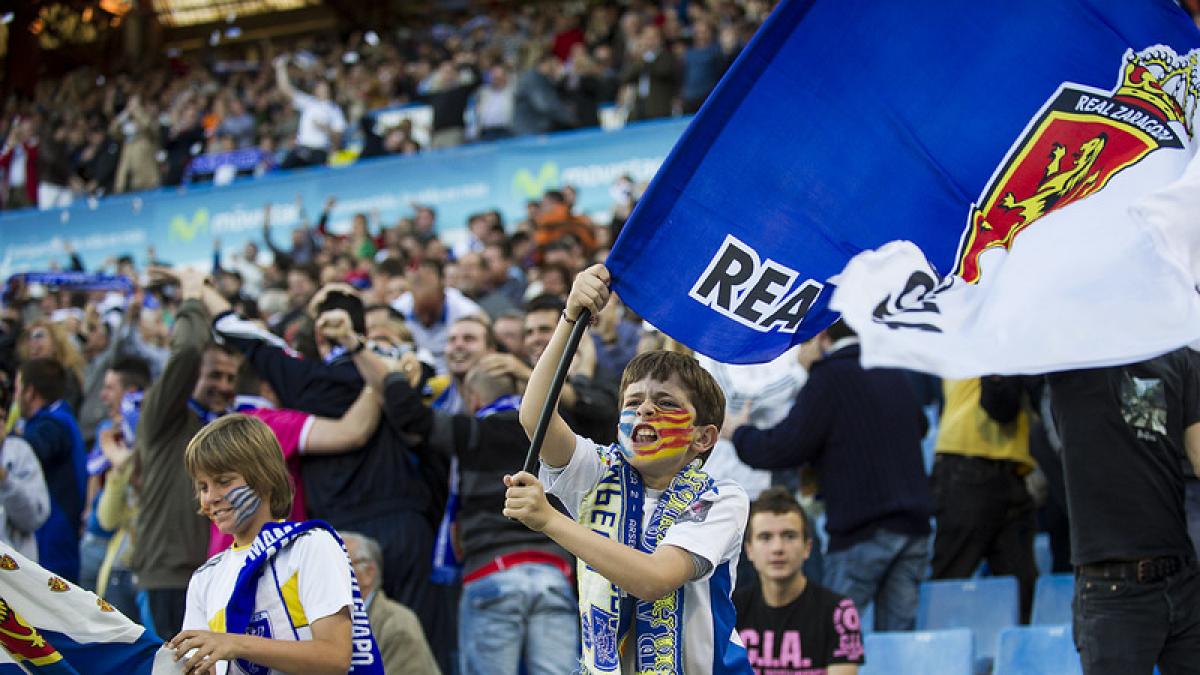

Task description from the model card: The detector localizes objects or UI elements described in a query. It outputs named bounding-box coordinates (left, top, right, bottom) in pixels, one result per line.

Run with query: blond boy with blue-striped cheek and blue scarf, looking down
left=167, top=414, right=383, bottom=675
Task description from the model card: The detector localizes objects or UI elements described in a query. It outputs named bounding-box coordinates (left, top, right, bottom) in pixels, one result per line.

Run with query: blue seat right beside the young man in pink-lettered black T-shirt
left=858, top=628, right=974, bottom=675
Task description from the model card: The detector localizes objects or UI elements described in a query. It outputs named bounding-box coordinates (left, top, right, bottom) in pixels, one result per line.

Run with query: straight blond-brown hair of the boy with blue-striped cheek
left=184, top=414, right=293, bottom=518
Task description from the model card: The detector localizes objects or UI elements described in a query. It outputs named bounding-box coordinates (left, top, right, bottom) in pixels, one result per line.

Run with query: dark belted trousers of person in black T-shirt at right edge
left=1073, top=565, right=1200, bottom=675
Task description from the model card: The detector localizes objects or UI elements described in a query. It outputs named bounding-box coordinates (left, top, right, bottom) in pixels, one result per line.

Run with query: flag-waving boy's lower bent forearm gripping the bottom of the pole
left=504, top=471, right=697, bottom=602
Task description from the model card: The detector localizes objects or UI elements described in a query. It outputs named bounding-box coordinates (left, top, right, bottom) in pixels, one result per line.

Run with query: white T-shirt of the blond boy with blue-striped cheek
left=184, top=530, right=354, bottom=675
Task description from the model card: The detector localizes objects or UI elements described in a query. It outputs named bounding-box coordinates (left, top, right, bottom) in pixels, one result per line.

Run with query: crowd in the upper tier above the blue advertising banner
left=0, top=0, right=768, bottom=209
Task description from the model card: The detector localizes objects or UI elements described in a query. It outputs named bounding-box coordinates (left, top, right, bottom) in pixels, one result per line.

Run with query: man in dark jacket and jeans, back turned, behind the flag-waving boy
left=725, top=321, right=931, bottom=631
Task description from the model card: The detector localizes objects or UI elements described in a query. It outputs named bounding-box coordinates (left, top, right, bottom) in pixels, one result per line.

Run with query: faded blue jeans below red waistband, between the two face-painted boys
left=458, top=565, right=580, bottom=675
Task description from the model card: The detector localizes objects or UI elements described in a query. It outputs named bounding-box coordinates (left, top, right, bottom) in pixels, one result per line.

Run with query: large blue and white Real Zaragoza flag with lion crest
left=608, top=0, right=1200, bottom=376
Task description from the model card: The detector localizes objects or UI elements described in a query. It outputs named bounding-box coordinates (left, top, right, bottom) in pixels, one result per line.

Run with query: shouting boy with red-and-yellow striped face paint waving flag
left=504, top=265, right=752, bottom=675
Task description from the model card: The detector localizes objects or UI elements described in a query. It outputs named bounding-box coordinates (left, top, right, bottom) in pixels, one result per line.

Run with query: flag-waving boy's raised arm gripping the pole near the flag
left=521, top=264, right=611, bottom=467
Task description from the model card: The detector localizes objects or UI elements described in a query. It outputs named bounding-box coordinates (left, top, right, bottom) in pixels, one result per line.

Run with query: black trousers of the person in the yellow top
left=932, top=454, right=1038, bottom=623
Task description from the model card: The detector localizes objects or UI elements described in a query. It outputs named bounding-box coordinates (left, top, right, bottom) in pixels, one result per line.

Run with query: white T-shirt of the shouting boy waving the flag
left=538, top=436, right=750, bottom=673
